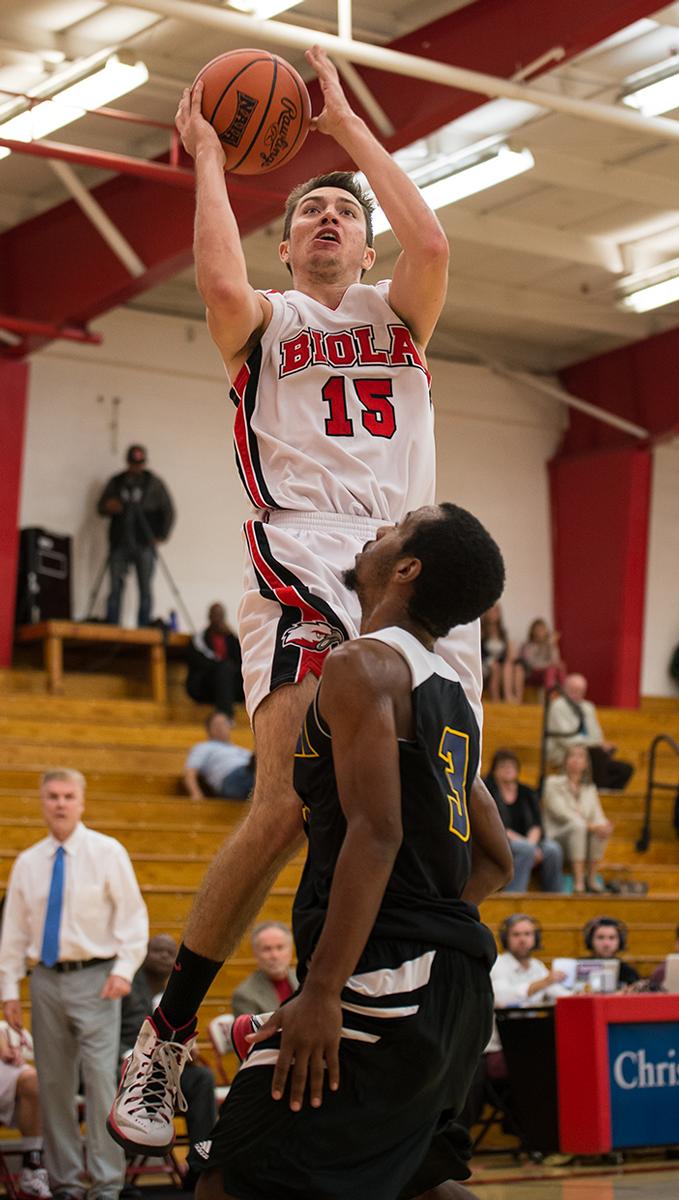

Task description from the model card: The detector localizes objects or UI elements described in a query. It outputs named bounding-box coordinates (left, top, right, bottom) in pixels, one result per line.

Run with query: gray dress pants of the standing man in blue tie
left=30, top=962, right=125, bottom=1200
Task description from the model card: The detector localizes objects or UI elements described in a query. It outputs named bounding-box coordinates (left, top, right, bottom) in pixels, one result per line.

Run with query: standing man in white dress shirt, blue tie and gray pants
left=0, top=770, right=149, bottom=1200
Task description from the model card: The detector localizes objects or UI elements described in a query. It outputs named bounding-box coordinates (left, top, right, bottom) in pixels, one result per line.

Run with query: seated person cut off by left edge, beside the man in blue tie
left=0, top=1021, right=52, bottom=1200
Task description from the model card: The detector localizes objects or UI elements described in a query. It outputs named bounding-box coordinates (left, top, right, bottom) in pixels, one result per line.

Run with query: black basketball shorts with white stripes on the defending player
left=191, top=941, right=493, bottom=1200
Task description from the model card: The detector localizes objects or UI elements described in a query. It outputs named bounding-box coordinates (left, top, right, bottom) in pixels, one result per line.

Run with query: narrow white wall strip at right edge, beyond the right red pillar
left=642, top=438, right=679, bottom=696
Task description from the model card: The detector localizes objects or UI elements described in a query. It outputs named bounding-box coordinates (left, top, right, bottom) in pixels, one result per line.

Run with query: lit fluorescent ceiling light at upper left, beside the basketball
left=0, top=54, right=149, bottom=158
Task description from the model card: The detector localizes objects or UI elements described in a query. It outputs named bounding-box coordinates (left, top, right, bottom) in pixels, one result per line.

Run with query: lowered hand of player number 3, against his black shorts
left=247, top=992, right=342, bottom=1112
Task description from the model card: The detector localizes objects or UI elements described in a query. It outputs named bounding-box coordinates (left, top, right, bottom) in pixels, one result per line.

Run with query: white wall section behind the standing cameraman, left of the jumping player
left=20, top=310, right=254, bottom=629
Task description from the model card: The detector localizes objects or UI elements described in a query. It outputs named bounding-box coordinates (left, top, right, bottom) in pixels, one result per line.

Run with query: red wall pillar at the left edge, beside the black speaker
left=0, top=360, right=29, bottom=667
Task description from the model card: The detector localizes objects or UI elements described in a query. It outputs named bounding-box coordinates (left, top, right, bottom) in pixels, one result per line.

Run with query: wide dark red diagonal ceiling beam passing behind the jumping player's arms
left=0, top=0, right=657, bottom=353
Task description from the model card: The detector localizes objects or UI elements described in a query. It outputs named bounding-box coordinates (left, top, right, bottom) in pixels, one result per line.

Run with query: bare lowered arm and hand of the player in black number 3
left=251, top=643, right=407, bottom=1111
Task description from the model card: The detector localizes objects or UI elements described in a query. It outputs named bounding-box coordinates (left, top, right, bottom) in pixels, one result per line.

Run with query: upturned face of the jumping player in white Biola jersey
left=281, top=187, right=375, bottom=282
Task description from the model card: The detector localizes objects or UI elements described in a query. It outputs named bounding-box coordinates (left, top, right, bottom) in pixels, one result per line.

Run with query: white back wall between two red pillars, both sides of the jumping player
left=20, top=310, right=565, bottom=641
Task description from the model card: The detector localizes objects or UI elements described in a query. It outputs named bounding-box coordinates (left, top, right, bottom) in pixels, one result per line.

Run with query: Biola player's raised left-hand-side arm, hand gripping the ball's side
left=175, top=80, right=271, bottom=367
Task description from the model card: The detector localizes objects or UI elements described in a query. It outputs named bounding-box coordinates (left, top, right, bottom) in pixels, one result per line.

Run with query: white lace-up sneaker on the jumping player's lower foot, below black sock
left=106, top=1016, right=196, bottom=1154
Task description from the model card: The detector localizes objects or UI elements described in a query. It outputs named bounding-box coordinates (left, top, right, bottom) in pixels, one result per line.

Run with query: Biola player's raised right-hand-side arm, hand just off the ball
left=306, top=46, right=449, bottom=349
